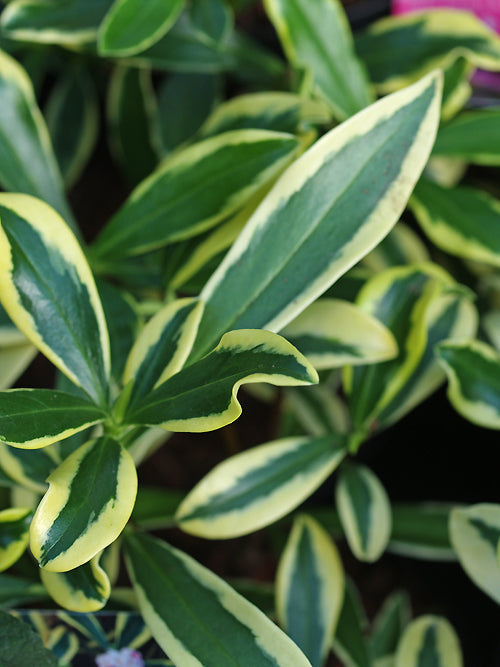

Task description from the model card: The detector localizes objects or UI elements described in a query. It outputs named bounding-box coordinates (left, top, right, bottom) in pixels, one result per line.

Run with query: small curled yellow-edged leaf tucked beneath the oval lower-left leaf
left=40, top=554, right=111, bottom=613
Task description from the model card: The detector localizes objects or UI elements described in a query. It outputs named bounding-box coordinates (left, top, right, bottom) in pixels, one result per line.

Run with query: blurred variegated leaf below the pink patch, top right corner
left=356, top=9, right=500, bottom=93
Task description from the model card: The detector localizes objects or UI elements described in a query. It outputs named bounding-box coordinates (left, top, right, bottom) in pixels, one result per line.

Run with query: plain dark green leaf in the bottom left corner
left=0, top=611, right=59, bottom=667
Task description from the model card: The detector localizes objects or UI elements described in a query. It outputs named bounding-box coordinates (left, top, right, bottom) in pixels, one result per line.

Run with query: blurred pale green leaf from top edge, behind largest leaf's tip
left=264, top=0, right=373, bottom=119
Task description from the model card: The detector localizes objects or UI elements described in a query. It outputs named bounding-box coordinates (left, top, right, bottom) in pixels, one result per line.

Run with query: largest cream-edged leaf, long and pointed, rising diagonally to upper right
left=196, top=74, right=440, bottom=354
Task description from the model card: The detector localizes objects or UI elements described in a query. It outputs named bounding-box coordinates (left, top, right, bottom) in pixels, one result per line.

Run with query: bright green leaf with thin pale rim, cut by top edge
left=97, top=0, right=184, bottom=56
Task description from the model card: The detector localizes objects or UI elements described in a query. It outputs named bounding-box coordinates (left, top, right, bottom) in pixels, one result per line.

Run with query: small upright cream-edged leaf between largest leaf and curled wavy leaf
left=123, top=299, right=203, bottom=402
